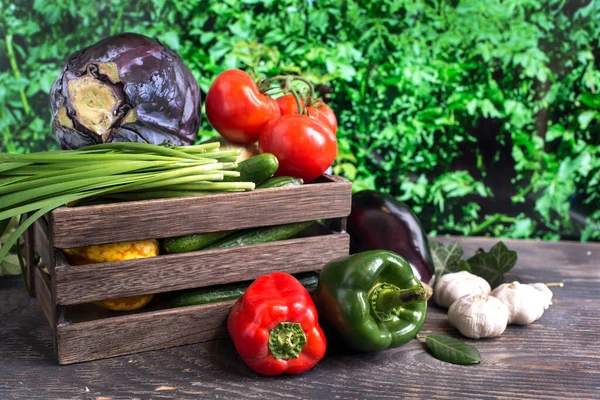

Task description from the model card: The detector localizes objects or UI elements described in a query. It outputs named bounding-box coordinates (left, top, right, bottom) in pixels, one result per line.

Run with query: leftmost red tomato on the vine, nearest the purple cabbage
left=206, top=69, right=280, bottom=144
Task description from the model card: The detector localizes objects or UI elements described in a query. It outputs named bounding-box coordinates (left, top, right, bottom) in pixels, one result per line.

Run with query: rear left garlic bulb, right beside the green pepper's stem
left=434, top=271, right=492, bottom=308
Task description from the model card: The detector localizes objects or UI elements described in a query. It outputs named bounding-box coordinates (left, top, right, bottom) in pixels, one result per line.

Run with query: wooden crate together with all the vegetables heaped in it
left=0, top=33, right=351, bottom=363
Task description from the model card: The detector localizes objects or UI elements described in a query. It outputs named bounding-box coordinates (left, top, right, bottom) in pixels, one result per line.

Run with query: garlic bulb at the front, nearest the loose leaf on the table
left=448, top=294, right=508, bottom=339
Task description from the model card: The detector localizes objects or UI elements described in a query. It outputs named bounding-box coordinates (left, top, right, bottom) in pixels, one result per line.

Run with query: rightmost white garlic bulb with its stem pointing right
left=492, top=282, right=552, bottom=325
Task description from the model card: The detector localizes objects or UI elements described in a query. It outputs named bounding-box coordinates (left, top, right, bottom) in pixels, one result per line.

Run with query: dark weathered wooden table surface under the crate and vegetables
left=0, top=238, right=600, bottom=399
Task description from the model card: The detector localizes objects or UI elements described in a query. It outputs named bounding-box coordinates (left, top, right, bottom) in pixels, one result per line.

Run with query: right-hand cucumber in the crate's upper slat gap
left=205, top=221, right=313, bottom=249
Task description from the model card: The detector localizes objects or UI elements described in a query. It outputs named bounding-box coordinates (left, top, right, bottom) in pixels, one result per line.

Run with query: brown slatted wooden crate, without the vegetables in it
left=25, top=175, right=352, bottom=364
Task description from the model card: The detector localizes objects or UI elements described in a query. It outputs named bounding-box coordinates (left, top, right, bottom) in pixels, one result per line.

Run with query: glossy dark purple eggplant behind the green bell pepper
left=347, top=190, right=435, bottom=285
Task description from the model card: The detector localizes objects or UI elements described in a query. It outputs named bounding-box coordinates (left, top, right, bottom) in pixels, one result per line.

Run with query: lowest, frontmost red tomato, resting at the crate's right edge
left=259, top=114, right=337, bottom=182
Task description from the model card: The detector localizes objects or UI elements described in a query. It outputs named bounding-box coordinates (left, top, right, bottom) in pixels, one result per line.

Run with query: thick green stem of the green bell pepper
left=369, top=283, right=427, bottom=321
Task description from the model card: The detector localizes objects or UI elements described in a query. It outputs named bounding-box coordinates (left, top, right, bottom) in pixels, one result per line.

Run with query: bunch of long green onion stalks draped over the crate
left=0, top=142, right=254, bottom=262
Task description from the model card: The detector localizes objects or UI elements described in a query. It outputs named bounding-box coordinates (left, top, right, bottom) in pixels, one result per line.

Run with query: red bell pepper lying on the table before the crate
left=227, top=272, right=326, bottom=375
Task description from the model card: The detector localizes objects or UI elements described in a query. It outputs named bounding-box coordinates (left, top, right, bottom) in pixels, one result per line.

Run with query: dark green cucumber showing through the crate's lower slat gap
left=169, top=272, right=319, bottom=307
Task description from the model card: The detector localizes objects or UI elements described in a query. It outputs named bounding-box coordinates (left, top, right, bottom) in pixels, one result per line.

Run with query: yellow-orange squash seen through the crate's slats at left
left=65, top=239, right=158, bottom=311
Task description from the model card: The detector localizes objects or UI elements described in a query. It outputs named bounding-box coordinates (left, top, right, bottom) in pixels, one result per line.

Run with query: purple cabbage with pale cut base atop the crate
left=50, top=33, right=201, bottom=149
